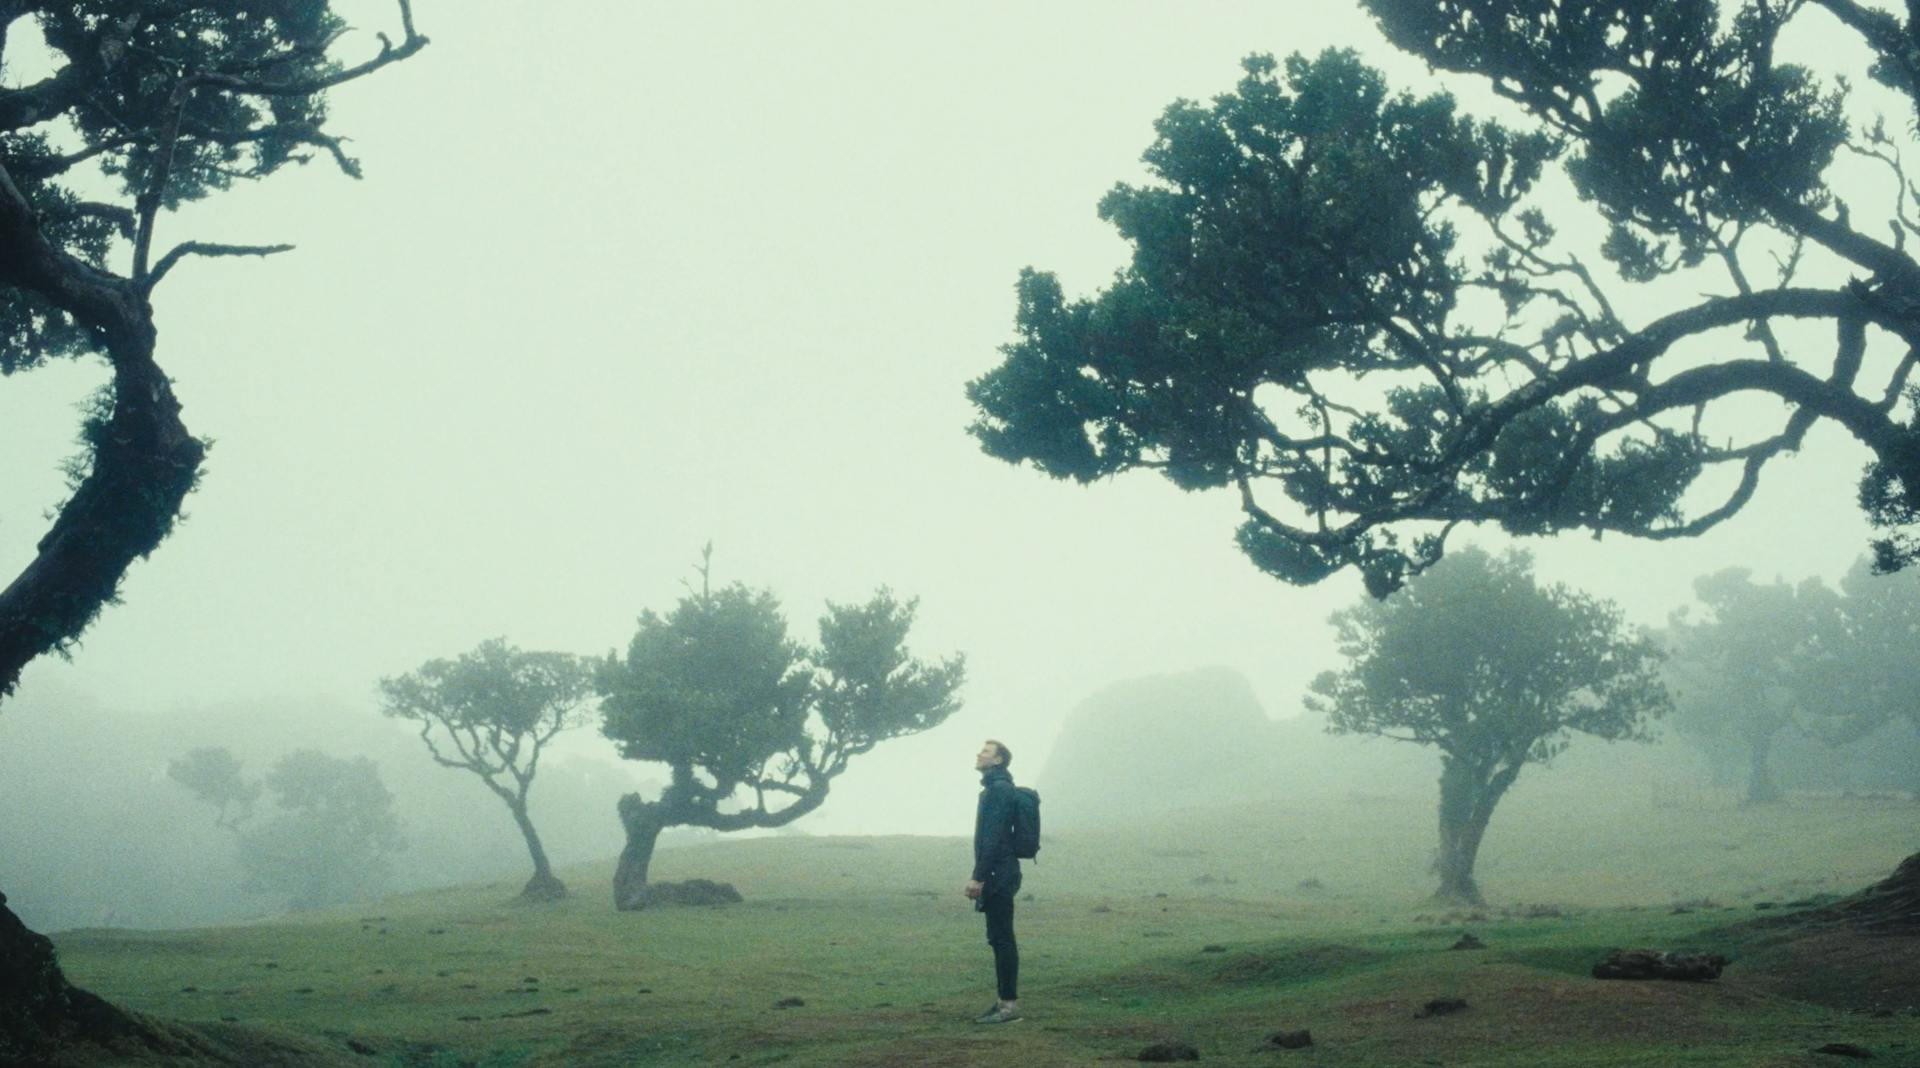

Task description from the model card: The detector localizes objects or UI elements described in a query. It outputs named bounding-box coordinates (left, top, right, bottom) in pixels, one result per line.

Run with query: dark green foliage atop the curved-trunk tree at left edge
left=0, top=0, right=424, bottom=373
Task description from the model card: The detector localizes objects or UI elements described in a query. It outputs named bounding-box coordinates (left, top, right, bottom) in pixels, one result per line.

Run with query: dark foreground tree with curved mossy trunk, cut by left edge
left=0, top=0, right=426, bottom=1060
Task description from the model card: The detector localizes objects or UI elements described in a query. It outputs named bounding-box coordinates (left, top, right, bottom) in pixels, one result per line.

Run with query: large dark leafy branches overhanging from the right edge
left=968, top=0, right=1920, bottom=595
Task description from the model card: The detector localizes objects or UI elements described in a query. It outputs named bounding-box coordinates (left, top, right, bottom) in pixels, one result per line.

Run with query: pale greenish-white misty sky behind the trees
left=0, top=0, right=1889, bottom=834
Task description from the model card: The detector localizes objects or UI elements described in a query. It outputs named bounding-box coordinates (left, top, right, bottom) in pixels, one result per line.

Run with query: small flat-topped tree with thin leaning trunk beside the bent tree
left=380, top=638, right=593, bottom=901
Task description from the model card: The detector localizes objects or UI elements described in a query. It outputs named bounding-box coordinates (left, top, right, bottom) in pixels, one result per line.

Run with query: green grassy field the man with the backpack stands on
left=45, top=797, right=1920, bottom=1068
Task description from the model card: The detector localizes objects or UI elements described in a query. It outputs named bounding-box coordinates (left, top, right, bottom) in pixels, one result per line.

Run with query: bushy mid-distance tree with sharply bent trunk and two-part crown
left=597, top=549, right=964, bottom=909
